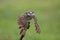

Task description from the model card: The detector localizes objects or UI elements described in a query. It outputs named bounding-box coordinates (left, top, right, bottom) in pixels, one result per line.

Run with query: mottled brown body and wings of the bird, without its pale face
left=18, top=12, right=40, bottom=40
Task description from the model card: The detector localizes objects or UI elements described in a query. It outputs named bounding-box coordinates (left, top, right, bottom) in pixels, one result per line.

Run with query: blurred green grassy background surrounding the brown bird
left=0, top=0, right=60, bottom=40
